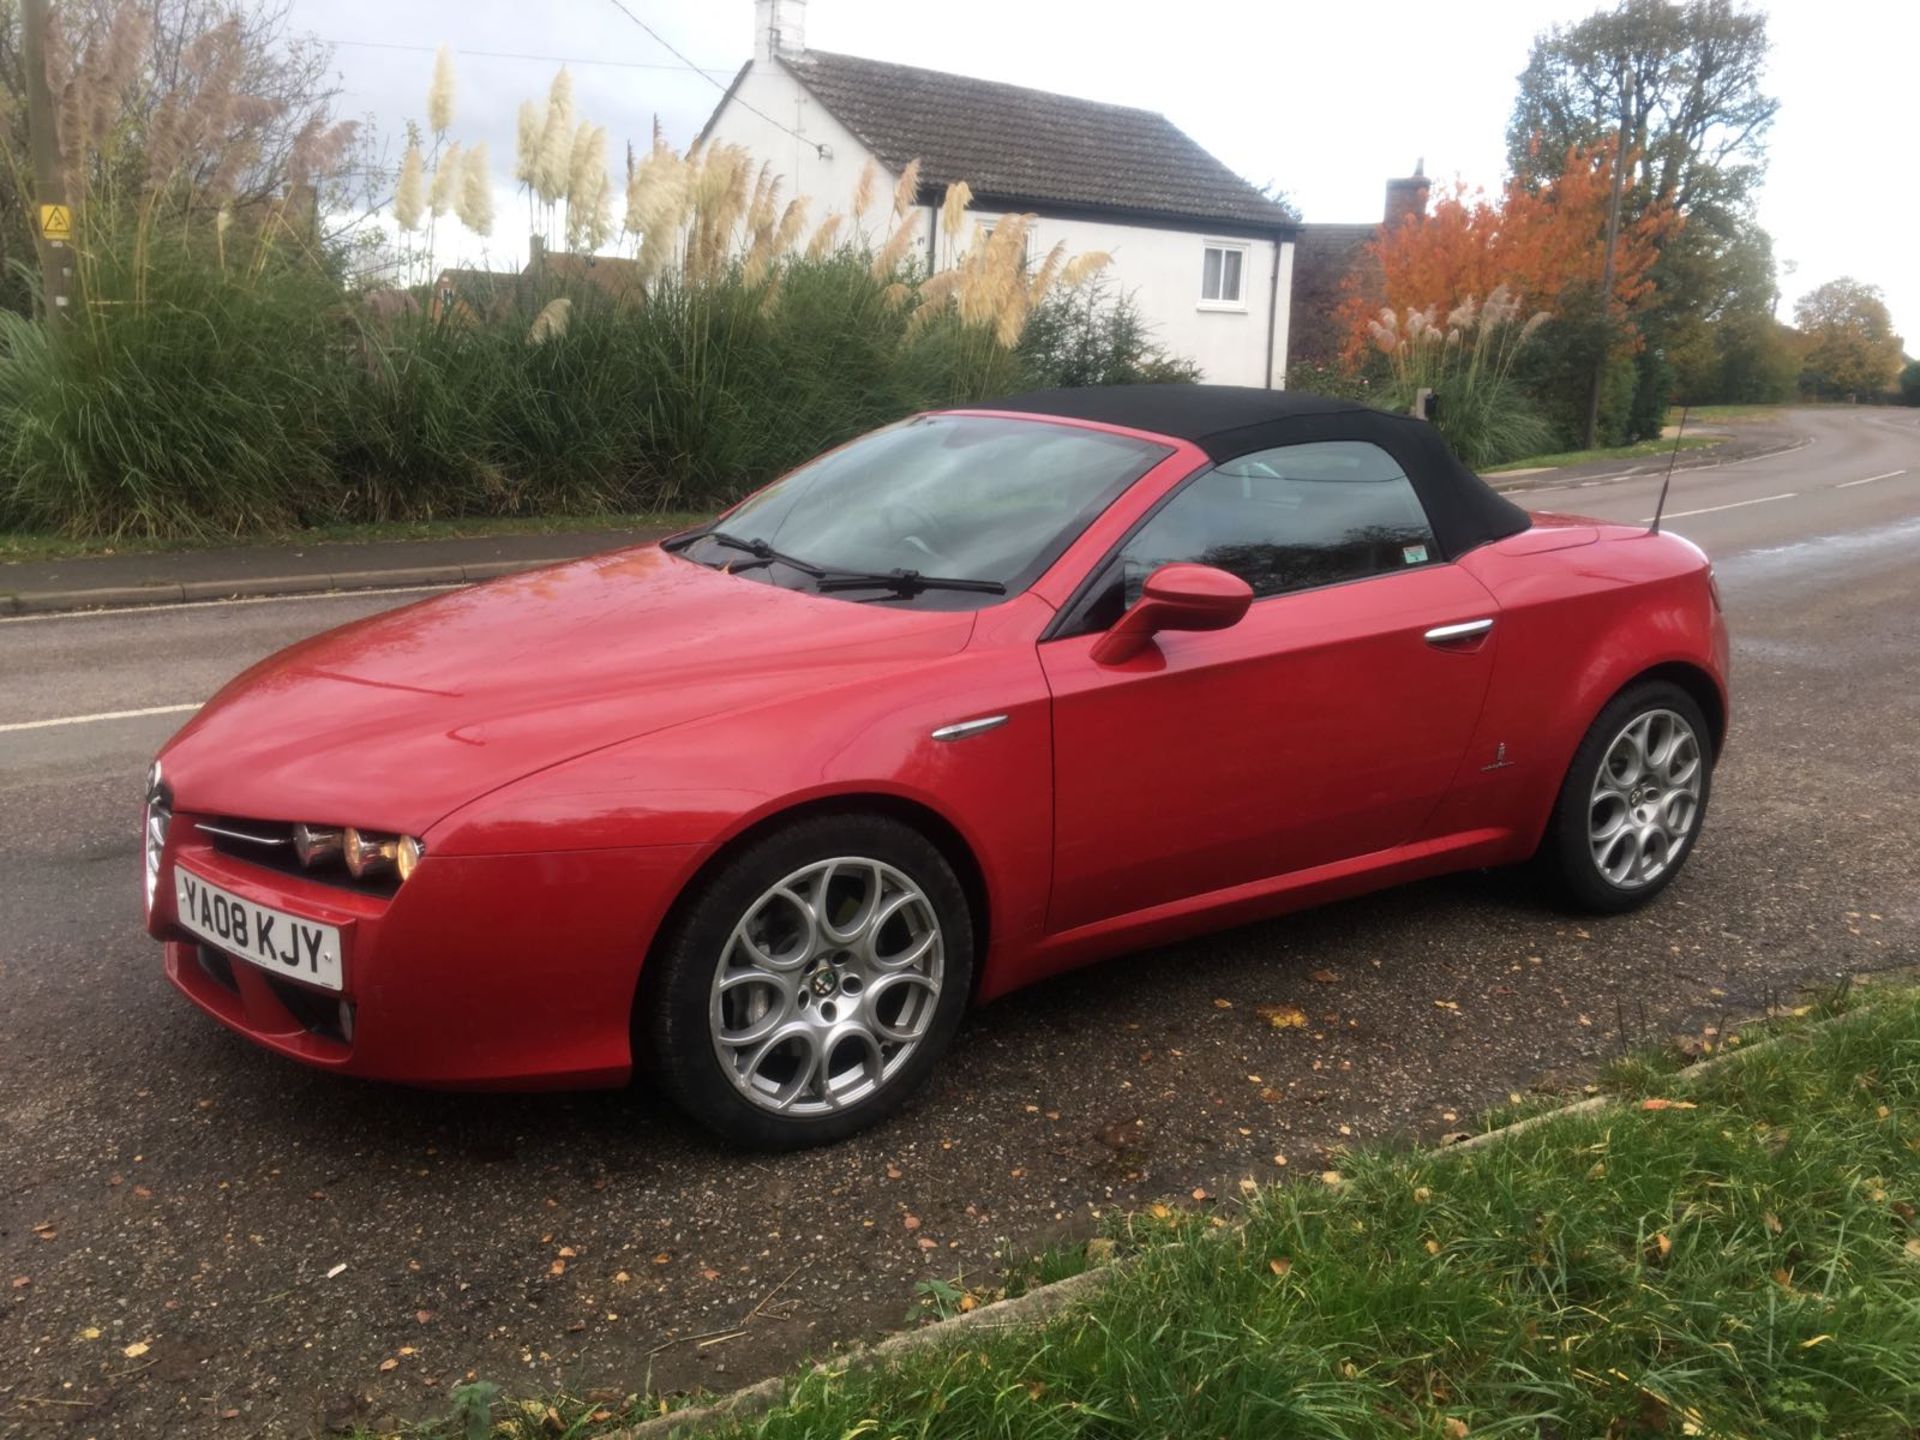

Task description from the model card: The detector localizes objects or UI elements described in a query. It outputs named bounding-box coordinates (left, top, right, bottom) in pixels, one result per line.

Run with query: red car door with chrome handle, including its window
left=1041, top=440, right=1498, bottom=931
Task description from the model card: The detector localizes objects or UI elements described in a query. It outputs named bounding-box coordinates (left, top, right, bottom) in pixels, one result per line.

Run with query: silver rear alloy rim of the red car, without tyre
left=1588, top=708, right=1707, bottom=891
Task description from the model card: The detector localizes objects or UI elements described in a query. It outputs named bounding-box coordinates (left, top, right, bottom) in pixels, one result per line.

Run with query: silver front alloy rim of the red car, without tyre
left=708, top=856, right=947, bottom=1116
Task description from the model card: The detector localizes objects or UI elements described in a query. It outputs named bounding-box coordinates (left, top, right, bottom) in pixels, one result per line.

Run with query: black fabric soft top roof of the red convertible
left=979, top=384, right=1532, bottom=559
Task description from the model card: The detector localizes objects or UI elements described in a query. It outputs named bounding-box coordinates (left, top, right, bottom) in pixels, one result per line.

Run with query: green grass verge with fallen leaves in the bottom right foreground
left=370, top=991, right=1920, bottom=1440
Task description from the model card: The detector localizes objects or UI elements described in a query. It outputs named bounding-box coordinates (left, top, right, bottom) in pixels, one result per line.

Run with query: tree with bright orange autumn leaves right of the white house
left=1340, top=144, right=1680, bottom=363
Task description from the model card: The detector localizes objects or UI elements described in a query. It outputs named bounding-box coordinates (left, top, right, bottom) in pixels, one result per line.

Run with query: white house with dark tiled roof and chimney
left=701, top=0, right=1296, bottom=388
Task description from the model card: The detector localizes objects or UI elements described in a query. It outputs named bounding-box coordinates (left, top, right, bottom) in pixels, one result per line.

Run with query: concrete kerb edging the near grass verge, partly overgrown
left=603, top=977, right=1876, bottom=1440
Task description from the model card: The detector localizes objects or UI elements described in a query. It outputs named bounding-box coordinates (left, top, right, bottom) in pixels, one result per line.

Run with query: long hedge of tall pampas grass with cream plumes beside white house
left=0, top=135, right=1167, bottom=540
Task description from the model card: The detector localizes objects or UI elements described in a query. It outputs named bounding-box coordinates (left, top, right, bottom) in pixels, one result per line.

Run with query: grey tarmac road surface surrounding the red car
left=0, top=411, right=1920, bottom=1436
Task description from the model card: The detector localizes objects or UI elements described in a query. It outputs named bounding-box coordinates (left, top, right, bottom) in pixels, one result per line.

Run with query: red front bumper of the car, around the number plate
left=148, top=810, right=703, bottom=1089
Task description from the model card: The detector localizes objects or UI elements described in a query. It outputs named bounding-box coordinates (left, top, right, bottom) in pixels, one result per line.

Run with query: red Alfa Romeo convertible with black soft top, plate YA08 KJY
left=146, top=386, right=1728, bottom=1146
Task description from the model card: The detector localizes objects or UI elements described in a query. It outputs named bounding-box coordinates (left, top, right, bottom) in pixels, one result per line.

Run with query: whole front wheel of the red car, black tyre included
left=636, top=816, right=973, bottom=1150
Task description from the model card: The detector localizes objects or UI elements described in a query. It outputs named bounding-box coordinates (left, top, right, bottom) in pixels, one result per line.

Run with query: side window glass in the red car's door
left=1075, top=440, right=1440, bottom=632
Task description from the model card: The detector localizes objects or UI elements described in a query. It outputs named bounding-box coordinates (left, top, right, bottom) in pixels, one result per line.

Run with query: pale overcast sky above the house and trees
left=294, top=0, right=1920, bottom=351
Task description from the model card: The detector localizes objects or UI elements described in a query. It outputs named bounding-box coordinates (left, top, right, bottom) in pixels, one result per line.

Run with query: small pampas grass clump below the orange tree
left=1367, top=286, right=1551, bottom=468
